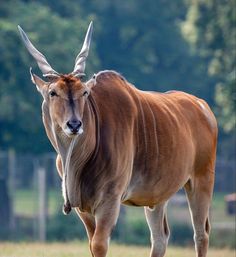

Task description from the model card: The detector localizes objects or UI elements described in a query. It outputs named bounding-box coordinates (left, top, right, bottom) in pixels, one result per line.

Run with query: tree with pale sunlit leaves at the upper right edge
left=182, top=0, right=236, bottom=134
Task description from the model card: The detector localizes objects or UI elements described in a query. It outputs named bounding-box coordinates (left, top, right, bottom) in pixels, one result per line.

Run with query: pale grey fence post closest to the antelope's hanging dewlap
left=38, top=168, right=47, bottom=242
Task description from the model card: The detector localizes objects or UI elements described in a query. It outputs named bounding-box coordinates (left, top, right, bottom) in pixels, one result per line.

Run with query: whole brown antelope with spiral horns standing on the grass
left=19, top=23, right=217, bottom=257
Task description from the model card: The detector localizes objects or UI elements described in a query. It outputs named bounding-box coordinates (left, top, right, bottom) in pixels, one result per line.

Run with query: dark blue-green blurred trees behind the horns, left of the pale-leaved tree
left=0, top=0, right=214, bottom=152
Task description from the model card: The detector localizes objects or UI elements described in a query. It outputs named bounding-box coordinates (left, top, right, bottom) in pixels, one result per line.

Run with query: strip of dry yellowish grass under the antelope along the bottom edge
left=0, top=242, right=235, bottom=257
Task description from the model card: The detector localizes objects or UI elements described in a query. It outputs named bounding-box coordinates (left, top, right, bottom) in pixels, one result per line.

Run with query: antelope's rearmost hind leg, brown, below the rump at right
left=185, top=171, right=214, bottom=257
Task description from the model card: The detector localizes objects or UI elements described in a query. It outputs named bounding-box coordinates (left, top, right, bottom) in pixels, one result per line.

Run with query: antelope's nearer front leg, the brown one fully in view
left=91, top=200, right=120, bottom=257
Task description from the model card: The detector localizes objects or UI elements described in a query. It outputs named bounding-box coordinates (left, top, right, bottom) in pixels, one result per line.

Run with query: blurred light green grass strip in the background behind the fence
left=13, top=188, right=234, bottom=223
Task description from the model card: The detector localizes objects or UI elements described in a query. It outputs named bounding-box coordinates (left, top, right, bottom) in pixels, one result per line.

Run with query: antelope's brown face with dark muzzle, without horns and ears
left=44, top=75, right=89, bottom=137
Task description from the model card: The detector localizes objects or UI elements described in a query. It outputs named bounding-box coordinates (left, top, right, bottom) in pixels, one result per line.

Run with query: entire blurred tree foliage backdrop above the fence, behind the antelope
left=0, top=0, right=235, bottom=155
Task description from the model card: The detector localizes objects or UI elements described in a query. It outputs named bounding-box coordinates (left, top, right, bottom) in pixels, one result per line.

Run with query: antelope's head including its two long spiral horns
left=18, top=22, right=93, bottom=137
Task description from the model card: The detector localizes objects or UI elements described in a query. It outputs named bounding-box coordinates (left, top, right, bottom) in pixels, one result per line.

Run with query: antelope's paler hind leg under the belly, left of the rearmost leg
left=145, top=203, right=170, bottom=257
